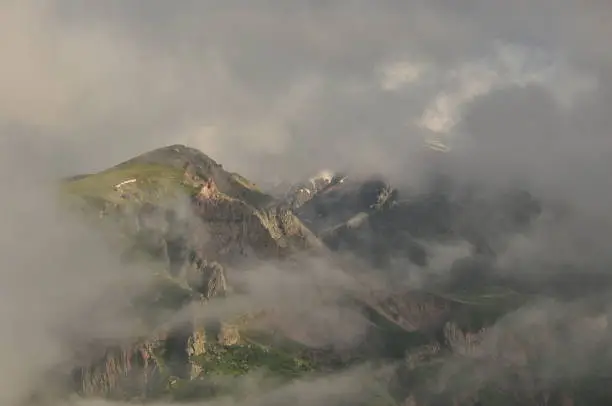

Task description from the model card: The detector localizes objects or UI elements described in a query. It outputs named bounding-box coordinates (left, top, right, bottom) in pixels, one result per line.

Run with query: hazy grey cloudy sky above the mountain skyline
left=0, top=0, right=612, bottom=187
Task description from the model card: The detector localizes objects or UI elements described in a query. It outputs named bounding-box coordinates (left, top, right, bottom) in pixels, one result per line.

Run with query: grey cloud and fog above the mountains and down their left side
left=0, top=0, right=612, bottom=405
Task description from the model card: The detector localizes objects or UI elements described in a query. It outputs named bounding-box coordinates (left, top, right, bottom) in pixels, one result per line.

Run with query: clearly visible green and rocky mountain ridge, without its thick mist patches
left=41, top=145, right=612, bottom=406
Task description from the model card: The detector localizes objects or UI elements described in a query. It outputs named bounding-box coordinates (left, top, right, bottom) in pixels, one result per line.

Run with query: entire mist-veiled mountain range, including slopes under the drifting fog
left=28, top=145, right=612, bottom=406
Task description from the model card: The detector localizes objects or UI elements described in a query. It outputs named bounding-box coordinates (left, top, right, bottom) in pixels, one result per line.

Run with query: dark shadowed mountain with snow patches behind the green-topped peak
left=294, top=170, right=541, bottom=268
